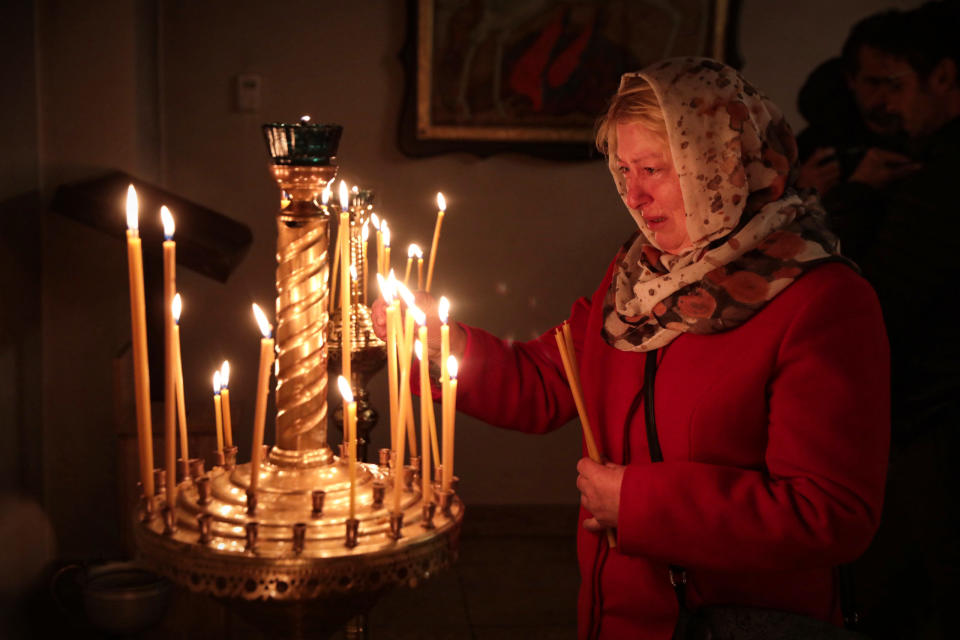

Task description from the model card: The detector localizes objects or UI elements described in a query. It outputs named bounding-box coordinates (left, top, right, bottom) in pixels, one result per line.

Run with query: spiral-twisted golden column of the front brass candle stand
left=273, top=165, right=337, bottom=461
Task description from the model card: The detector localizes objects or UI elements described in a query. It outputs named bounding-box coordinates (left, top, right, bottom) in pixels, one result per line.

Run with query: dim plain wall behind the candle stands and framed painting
left=0, top=0, right=918, bottom=555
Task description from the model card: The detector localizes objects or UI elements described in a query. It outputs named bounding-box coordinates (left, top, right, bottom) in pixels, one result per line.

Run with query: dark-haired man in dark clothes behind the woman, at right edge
left=823, top=2, right=960, bottom=638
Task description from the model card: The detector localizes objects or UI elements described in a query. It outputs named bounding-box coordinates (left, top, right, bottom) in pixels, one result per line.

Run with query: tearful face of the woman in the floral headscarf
left=614, top=123, right=692, bottom=254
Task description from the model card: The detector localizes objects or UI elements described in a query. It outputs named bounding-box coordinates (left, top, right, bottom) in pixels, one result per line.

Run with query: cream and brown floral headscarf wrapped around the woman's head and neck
left=603, top=58, right=845, bottom=351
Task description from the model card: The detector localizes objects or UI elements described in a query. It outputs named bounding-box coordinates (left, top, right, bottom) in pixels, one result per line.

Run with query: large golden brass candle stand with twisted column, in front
left=135, top=122, right=464, bottom=637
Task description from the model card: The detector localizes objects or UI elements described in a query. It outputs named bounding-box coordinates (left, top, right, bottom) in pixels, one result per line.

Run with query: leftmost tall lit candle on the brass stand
left=127, top=185, right=153, bottom=499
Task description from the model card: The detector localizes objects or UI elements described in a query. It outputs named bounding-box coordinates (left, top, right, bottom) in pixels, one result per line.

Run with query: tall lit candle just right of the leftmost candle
left=160, top=206, right=177, bottom=507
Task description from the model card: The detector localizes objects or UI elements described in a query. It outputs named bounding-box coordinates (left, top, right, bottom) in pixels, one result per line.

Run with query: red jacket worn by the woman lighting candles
left=457, top=263, right=890, bottom=638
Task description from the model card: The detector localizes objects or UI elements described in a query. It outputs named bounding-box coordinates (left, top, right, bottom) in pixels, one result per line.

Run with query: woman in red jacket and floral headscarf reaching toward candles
left=380, top=58, right=889, bottom=638
